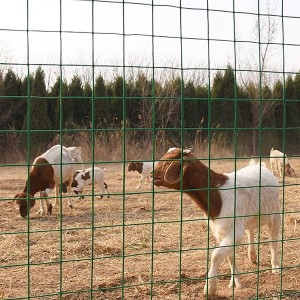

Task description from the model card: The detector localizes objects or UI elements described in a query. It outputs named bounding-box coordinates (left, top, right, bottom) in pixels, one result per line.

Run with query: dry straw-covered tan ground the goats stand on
left=0, top=159, right=300, bottom=300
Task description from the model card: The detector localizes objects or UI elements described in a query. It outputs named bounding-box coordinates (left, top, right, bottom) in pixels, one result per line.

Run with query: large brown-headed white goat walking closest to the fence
left=152, top=148, right=281, bottom=296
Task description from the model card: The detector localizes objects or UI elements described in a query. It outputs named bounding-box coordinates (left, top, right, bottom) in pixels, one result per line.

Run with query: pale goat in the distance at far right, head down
left=270, top=148, right=296, bottom=178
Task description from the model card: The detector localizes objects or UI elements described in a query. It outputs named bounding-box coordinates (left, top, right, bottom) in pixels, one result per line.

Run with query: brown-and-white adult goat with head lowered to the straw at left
left=15, top=145, right=75, bottom=217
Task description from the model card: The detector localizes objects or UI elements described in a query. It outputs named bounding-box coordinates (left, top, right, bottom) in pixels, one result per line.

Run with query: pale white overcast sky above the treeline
left=0, top=0, right=300, bottom=84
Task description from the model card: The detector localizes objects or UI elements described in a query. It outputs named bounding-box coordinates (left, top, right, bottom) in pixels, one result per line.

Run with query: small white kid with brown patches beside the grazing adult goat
left=71, top=167, right=109, bottom=199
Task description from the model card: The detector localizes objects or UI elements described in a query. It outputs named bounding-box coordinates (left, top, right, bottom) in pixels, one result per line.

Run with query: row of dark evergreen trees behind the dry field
left=0, top=66, right=300, bottom=158
